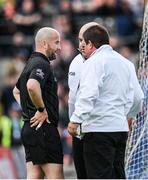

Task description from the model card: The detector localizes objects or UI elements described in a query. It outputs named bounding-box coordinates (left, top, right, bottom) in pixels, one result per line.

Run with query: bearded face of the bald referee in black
left=46, top=32, right=61, bottom=60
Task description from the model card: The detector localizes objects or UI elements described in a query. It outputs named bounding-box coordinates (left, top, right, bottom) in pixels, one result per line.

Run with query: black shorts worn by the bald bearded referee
left=21, top=122, right=63, bottom=164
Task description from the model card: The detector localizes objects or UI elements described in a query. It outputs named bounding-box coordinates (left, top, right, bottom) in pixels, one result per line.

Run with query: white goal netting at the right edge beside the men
left=125, top=1, right=148, bottom=179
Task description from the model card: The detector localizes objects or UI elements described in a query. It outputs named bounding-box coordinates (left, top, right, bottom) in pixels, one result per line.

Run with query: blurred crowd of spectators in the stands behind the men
left=0, top=0, right=144, bottom=178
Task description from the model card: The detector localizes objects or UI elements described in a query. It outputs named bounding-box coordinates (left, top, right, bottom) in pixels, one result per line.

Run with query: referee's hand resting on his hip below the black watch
left=30, top=110, right=48, bottom=127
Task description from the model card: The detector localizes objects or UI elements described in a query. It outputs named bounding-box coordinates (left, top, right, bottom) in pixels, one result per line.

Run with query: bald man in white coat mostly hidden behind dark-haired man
left=68, top=22, right=98, bottom=179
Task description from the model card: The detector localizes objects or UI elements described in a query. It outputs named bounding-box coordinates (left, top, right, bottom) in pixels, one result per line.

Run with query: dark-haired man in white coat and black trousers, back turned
left=68, top=22, right=143, bottom=179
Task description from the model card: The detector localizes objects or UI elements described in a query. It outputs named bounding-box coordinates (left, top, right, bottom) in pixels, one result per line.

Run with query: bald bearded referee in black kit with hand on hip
left=13, top=27, right=64, bottom=179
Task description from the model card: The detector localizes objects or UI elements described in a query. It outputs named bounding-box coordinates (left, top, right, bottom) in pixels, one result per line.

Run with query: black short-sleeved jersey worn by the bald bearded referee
left=16, top=52, right=59, bottom=126
